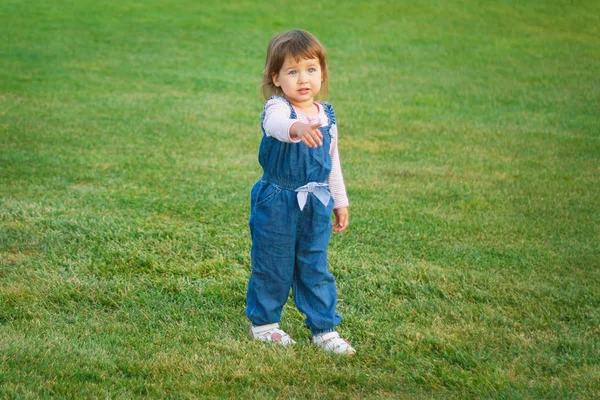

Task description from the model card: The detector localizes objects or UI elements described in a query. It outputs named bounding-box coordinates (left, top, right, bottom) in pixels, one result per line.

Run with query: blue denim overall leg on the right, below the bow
left=292, top=195, right=342, bottom=335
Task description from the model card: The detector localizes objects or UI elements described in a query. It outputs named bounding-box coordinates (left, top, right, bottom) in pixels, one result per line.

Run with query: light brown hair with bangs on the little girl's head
left=262, top=30, right=329, bottom=100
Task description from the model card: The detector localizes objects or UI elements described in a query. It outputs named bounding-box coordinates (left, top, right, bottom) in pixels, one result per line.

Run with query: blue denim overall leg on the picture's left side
left=246, top=184, right=295, bottom=326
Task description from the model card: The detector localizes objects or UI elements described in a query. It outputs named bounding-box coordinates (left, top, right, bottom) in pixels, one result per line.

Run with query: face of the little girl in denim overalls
left=272, top=56, right=323, bottom=110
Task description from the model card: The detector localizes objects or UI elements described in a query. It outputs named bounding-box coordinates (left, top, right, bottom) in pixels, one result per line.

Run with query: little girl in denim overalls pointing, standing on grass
left=246, top=30, right=356, bottom=355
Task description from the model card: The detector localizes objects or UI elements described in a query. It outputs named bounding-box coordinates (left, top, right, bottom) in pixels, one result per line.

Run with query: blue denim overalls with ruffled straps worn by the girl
left=246, top=94, right=342, bottom=335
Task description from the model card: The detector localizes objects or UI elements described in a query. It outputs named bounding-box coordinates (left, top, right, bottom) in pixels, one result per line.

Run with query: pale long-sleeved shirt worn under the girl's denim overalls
left=263, top=99, right=350, bottom=208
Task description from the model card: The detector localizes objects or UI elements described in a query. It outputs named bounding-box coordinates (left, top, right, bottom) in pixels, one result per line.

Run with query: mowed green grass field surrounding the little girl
left=0, top=0, right=600, bottom=399
